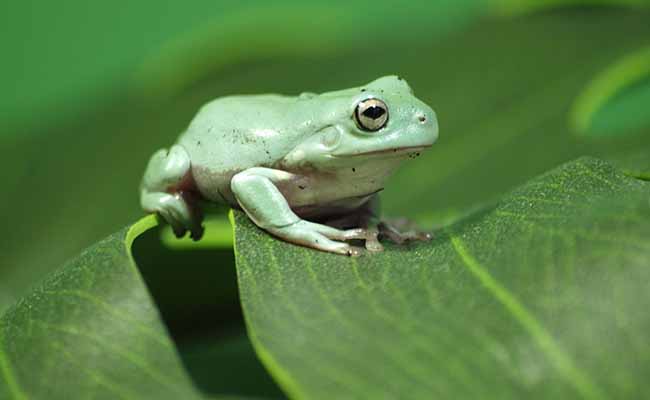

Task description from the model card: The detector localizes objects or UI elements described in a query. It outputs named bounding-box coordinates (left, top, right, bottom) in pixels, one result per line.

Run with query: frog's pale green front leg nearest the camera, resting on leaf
left=230, top=167, right=366, bottom=256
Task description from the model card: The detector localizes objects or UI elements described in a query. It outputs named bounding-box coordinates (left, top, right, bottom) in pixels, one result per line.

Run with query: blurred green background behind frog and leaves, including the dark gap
left=0, top=0, right=650, bottom=392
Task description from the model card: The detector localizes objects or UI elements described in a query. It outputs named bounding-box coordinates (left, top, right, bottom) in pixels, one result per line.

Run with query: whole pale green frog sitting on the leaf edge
left=140, top=75, right=438, bottom=256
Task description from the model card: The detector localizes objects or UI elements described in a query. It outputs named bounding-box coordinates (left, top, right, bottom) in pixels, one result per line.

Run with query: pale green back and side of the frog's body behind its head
left=178, top=95, right=300, bottom=202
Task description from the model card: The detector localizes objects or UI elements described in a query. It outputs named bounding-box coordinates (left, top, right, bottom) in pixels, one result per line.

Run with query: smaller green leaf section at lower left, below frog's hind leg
left=0, top=216, right=201, bottom=399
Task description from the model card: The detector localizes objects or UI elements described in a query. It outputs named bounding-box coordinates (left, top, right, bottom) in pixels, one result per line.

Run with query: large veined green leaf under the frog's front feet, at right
left=234, top=158, right=650, bottom=399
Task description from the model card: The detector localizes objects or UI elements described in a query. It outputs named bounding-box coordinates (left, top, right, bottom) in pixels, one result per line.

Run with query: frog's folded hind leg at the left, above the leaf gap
left=140, top=145, right=203, bottom=240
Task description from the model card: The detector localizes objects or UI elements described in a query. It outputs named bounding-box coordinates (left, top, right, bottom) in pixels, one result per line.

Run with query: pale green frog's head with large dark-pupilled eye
left=285, top=76, right=438, bottom=167
